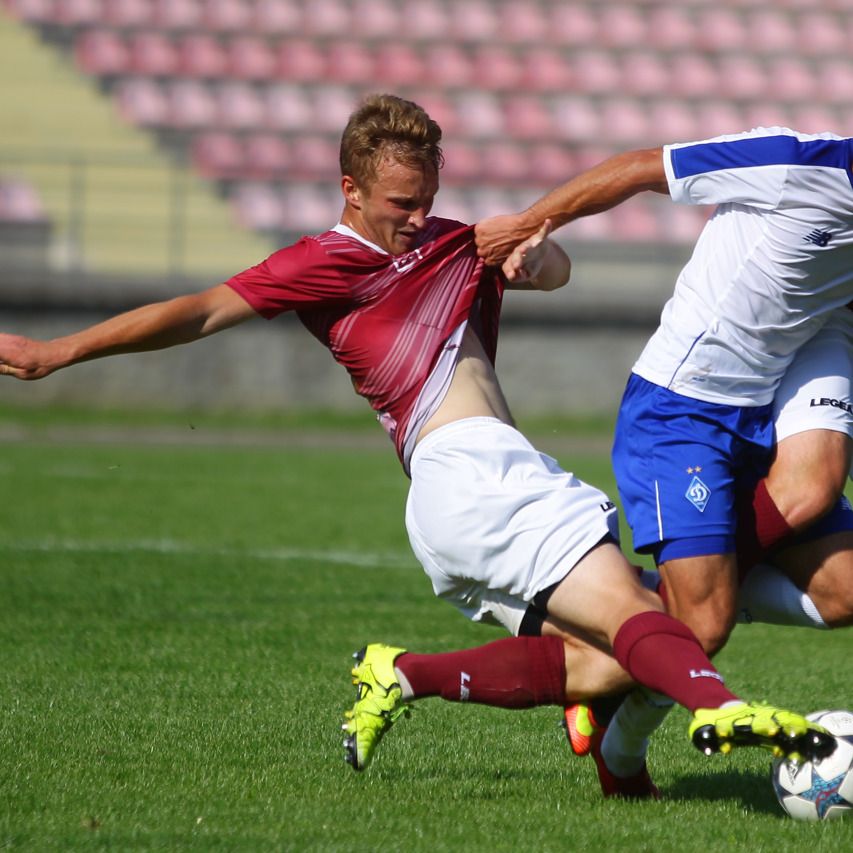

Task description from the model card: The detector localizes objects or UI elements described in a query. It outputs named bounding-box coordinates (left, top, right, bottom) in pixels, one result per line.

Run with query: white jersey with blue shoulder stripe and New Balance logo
left=634, top=128, right=853, bottom=406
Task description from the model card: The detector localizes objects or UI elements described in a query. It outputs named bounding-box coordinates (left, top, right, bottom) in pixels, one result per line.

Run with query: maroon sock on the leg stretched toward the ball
left=613, top=610, right=737, bottom=711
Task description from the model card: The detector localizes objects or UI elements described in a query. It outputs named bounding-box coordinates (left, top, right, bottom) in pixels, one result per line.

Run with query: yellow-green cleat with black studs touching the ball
left=688, top=702, right=835, bottom=761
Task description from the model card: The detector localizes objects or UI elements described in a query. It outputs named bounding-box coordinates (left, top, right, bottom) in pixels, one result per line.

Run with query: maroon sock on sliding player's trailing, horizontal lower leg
left=394, top=637, right=566, bottom=708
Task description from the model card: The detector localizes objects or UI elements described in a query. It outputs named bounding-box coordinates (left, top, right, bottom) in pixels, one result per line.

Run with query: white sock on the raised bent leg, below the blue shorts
left=737, top=564, right=827, bottom=628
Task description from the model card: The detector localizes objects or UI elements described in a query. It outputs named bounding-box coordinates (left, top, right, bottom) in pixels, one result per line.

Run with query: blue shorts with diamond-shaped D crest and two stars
left=613, top=374, right=774, bottom=563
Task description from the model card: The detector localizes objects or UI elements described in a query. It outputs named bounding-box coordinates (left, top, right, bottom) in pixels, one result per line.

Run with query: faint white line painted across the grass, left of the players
left=0, top=538, right=414, bottom=569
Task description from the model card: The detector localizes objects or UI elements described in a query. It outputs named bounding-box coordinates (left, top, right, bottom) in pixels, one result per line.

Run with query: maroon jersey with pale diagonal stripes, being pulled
left=227, top=217, right=503, bottom=460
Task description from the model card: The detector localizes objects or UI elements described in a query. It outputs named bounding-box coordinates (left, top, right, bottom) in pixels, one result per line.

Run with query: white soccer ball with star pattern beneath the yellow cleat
left=772, top=711, right=853, bottom=820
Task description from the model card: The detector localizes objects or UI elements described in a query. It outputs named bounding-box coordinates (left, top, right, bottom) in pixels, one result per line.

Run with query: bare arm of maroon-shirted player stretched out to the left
left=0, top=284, right=257, bottom=379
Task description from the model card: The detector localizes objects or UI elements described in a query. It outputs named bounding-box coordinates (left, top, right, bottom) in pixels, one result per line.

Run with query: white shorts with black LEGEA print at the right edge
left=773, top=308, right=853, bottom=442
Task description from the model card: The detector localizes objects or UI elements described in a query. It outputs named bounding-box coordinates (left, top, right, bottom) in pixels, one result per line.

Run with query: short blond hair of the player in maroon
left=340, top=95, right=444, bottom=187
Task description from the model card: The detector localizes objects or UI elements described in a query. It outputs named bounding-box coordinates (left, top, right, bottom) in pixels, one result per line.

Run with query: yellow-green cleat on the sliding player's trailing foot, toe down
left=341, top=643, right=412, bottom=770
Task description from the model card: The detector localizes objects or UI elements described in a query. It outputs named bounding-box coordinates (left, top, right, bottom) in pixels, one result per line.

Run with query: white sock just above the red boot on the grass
left=601, top=687, right=675, bottom=777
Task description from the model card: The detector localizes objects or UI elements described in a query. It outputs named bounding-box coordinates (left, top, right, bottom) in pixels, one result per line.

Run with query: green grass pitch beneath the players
left=0, top=409, right=853, bottom=853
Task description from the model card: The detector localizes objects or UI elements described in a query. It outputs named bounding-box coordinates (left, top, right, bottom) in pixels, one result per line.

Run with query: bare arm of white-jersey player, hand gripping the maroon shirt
left=474, top=148, right=669, bottom=264
